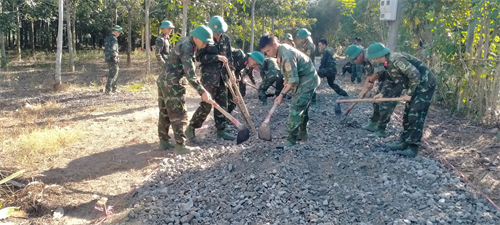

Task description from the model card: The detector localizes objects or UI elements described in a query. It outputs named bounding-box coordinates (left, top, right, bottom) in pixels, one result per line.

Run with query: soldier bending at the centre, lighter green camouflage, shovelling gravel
left=259, top=35, right=320, bottom=146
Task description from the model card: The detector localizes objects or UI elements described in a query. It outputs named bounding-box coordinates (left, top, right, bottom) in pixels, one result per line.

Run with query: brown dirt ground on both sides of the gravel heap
left=0, top=51, right=500, bottom=224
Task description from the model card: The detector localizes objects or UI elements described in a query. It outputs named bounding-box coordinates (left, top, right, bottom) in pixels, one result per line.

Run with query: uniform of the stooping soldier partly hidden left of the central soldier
left=258, top=58, right=284, bottom=103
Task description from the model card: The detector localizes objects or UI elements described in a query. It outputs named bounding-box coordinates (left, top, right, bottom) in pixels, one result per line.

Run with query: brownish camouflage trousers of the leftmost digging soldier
left=156, top=79, right=187, bottom=144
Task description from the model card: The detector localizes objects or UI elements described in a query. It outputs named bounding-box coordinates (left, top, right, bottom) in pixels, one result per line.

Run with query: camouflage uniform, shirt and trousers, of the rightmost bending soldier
left=380, top=52, right=436, bottom=146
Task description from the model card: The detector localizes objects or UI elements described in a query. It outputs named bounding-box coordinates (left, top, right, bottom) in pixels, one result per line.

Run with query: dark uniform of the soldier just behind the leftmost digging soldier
left=189, top=44, right=228, bottom=130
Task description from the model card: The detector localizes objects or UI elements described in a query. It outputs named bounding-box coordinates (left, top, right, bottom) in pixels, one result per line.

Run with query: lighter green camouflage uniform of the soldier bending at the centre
left=277, top=45, right=320, bottom=143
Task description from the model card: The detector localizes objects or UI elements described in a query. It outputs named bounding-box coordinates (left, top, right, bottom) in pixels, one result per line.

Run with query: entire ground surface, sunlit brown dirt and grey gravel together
left=0, top=55, right=500, bottom=224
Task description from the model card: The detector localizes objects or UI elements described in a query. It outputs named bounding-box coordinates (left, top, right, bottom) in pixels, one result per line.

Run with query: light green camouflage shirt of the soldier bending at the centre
left=277, top=44, right=319, bottom=85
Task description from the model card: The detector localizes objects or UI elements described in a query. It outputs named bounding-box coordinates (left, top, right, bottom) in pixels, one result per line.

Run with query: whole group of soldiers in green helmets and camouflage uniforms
left=105, top=16, right=435, bottom=157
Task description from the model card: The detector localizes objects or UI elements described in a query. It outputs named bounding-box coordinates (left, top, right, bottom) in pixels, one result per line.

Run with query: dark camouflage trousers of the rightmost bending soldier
left=401, top=70, right=436, bottom=145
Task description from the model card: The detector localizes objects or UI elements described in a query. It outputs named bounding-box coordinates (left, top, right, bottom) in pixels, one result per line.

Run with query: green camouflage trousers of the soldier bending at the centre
left=287, top=76, right=320, bottom=142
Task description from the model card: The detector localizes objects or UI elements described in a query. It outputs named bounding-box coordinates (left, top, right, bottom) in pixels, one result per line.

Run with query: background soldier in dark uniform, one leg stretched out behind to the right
left=318, top=39, right=349, bottom=96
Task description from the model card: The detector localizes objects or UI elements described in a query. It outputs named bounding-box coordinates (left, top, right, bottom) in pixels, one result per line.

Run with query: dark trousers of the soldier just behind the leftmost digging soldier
left=189, top=78, right=228, bottom=130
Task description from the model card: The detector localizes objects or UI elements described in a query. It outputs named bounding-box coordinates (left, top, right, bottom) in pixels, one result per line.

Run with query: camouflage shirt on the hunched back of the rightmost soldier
left=384, top=52, right=435, bottom=96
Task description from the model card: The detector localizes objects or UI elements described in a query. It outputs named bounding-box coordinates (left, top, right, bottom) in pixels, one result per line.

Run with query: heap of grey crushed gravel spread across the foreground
left=125, top=78, right=500, bottom=225
